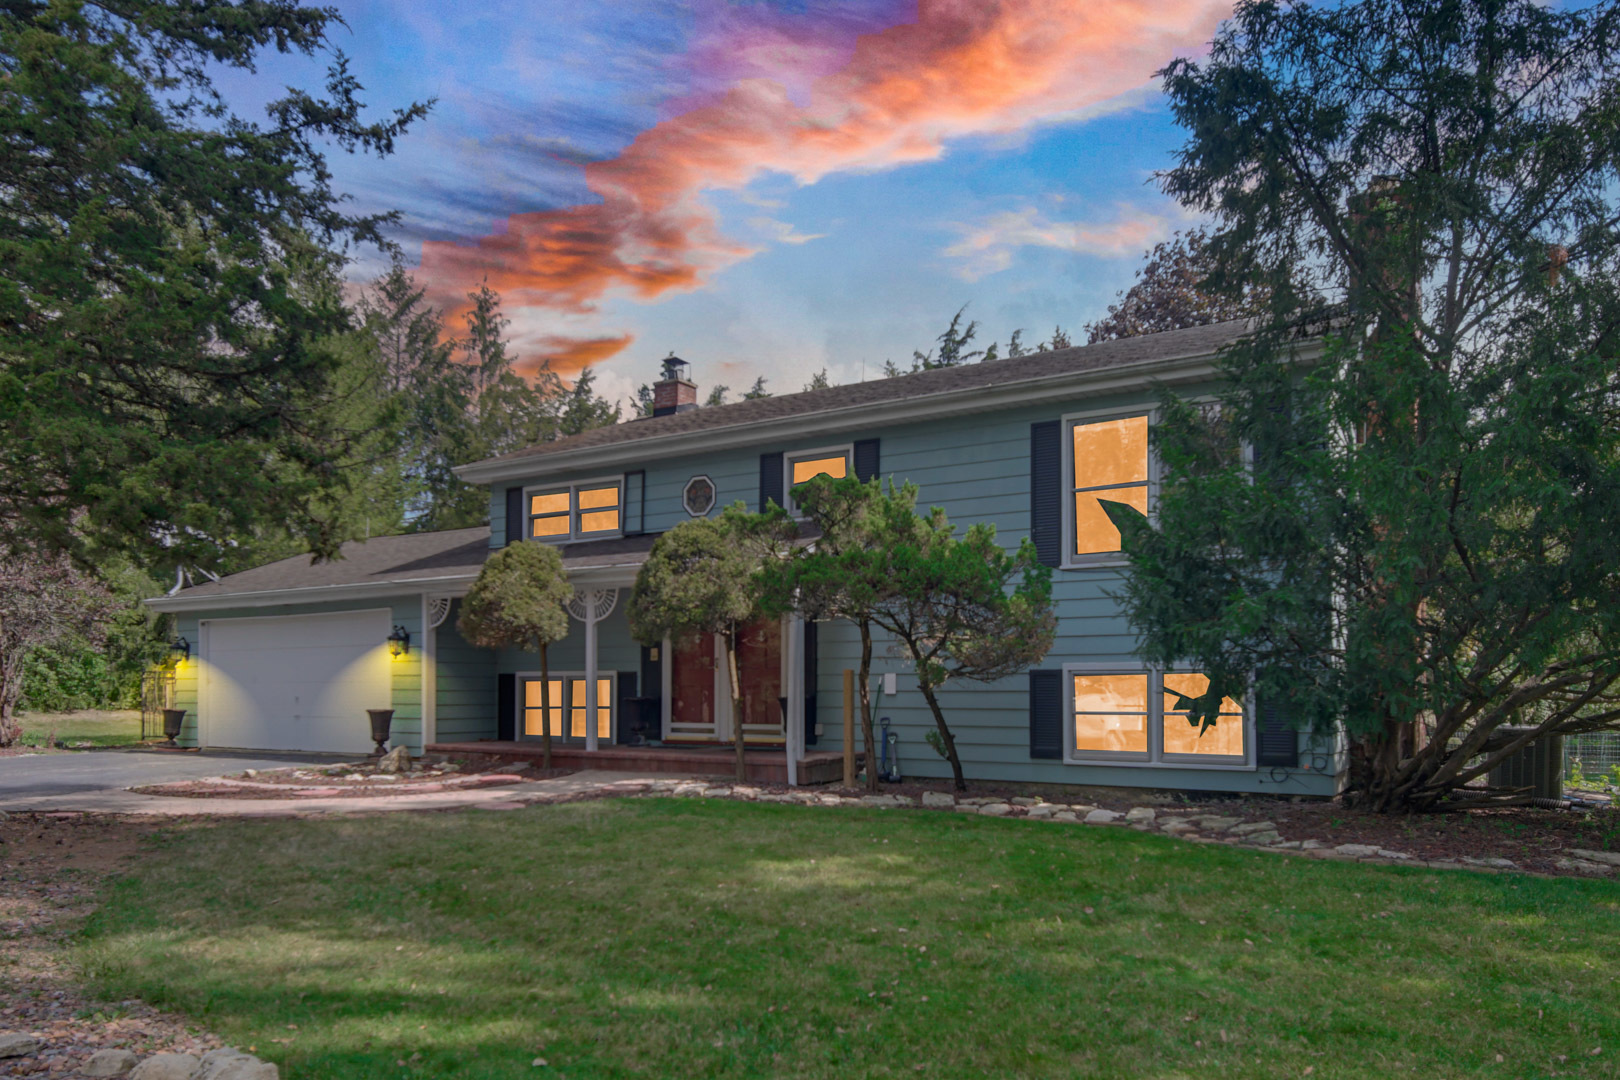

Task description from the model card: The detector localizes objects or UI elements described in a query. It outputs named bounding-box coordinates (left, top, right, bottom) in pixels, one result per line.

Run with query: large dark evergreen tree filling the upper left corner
left=0, top=0, right=426, bottom=565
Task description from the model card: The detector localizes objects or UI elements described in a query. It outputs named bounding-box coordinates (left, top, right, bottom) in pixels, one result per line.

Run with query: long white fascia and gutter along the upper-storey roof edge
left=452, top=353, right=1215, bottom=484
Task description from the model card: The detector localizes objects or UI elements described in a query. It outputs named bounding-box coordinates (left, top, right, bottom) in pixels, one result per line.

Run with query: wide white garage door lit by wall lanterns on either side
left=198, top=609, right=394, bottom=753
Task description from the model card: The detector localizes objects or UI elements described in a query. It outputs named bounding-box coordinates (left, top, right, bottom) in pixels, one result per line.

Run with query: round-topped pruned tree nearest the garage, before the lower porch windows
left=455, top=541, right=573, bottom=769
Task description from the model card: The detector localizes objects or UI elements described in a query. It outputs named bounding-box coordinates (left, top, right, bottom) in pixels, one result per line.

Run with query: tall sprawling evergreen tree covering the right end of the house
left=1115, top=0, right=1620, bottom=811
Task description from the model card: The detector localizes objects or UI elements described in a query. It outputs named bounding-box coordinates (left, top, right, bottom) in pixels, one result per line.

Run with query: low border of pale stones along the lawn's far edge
left=612, top=779, right=1620, bottom=878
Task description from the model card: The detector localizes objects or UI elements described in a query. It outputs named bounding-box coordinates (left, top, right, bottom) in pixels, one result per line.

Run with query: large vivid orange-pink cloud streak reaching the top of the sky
left=421, top=0, right=1231, bottom=320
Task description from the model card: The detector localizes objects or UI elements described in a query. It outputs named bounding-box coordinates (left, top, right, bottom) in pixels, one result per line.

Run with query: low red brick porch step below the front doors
left=424, top=738, right=844, bottom=784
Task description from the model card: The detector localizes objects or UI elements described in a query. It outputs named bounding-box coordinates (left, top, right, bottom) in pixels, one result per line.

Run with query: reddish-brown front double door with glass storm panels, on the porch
left=669, top=619, right=787, bottom=745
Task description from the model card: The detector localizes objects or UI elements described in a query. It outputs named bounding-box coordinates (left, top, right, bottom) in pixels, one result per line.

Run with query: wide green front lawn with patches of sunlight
left=83, top=800, right=1620, bottom=1080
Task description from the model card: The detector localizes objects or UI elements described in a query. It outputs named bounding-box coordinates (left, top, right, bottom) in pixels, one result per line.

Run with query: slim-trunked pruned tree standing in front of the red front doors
left=763, top=474, right=894, bottom=792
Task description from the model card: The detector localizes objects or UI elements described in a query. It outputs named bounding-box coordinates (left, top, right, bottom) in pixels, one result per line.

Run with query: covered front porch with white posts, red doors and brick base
left=424, top=538, right=842, bottom=784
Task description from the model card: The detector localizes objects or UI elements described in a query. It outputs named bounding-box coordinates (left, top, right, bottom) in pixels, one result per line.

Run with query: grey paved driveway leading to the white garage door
left=0, top=750, right=330, bottom=810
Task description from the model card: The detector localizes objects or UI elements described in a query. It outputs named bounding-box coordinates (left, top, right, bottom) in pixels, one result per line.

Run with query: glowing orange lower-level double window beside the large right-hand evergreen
left=1068, top=670, right=1247, bottom=764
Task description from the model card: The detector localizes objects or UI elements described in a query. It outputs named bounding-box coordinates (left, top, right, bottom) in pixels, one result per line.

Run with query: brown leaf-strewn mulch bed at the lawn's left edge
left=0, top=813, right=222, bottom=1077
